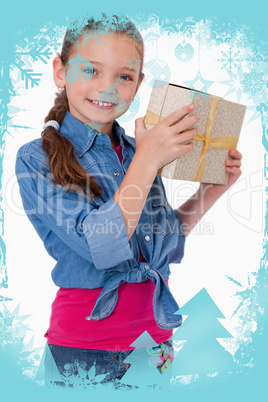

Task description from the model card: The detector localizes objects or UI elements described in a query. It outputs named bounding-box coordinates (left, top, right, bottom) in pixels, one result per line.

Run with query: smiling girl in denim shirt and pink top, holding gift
left=16, top=15, right=241, bottom=384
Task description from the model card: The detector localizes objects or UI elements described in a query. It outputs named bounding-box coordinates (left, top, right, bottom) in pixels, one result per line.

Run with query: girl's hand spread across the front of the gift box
left=135, top=104, right=199, bottom=170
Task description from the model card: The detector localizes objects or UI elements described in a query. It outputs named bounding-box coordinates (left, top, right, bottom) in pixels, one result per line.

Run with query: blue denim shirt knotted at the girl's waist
left=15, top=111, right=185, bottom=329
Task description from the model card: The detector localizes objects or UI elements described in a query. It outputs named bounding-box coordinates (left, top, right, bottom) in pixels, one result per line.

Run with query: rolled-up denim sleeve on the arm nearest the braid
left=15, top=153, right=133, bottom=270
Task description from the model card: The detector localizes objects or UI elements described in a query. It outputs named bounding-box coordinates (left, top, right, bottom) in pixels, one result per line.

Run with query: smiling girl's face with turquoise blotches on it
left=56, top=31, right=142, bottom=134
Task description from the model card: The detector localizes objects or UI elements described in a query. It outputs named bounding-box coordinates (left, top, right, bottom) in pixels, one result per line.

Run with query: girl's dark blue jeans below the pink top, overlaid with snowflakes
left=44, top=340, right=173, bottom=388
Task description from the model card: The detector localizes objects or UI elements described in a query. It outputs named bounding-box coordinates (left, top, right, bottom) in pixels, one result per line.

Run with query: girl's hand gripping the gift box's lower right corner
left=200, top=149, right=242, bottom=198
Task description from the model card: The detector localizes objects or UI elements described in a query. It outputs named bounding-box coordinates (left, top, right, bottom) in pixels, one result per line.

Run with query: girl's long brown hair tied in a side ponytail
left=41, top=14, right=144, bottom=201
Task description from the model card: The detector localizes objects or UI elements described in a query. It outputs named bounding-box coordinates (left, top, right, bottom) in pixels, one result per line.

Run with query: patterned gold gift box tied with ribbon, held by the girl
left=144, top=80, right=246, bottom=184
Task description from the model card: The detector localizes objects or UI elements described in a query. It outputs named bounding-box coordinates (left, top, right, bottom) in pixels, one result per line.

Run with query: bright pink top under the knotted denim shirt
left=44, top=145, right=173, bottom=350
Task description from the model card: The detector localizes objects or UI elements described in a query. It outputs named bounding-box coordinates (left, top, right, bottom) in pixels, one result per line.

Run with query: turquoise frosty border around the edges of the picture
left=0, top=0, right=268, bottom=401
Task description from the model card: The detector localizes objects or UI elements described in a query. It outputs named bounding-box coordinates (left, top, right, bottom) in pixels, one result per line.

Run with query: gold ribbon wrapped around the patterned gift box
left=144, top=96, right=239, bottom=181
